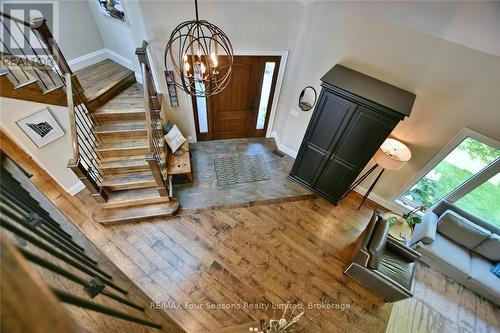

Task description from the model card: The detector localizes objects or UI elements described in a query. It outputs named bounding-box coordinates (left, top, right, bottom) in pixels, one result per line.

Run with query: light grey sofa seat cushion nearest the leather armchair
left=417, top=234, right=470, bottom=279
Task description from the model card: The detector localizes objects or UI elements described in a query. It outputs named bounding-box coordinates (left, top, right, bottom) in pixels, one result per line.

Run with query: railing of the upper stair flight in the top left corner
left=0, top=12, right=85, bottom=98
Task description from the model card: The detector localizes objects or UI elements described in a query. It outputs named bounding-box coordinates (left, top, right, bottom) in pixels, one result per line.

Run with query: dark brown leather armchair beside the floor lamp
left=344, top=211, right=420, bottom=302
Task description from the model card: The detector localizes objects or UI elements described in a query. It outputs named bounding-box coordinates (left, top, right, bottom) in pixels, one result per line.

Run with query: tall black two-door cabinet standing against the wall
left=290, top=65, right=415, bottom=204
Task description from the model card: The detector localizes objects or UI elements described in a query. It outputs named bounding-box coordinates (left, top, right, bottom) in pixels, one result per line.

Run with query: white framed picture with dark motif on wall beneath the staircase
left=16, top=107, right=64, bottom=148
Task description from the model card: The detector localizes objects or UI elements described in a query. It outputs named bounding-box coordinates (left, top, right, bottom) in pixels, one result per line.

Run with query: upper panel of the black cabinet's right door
left=335, top=107, right=392, bottom=166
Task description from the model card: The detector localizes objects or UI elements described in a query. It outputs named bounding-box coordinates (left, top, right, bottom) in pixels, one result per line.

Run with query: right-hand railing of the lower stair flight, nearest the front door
left=135, top=41, right=172, bottom=197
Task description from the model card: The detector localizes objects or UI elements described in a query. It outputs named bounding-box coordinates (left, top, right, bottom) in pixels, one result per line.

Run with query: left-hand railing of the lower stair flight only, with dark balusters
left=66, top=73, right=108, bottom=203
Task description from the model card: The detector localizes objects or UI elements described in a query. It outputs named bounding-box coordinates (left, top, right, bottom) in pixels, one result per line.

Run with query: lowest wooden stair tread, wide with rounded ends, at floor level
left=92, top=199, right=179, bottom=223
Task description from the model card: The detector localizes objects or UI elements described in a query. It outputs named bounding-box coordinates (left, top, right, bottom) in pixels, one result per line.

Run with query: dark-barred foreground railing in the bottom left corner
left=0, top=165, right=162, bottom=332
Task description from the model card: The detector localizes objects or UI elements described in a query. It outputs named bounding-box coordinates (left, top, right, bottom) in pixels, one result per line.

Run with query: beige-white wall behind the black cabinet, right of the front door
left=276, top=2, right=500, bottom=199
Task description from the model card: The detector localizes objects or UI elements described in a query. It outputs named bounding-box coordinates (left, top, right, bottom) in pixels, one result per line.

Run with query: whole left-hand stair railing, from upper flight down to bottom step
left=0, top=12, right=107, bottom=202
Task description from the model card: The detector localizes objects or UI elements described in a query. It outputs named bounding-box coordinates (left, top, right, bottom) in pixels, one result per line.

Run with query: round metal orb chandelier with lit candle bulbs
left=165, top=0, right=233, bottom=97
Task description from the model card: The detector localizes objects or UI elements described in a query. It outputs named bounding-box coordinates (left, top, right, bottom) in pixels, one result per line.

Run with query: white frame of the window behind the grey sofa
left=394, top=127, right=500, bottom=208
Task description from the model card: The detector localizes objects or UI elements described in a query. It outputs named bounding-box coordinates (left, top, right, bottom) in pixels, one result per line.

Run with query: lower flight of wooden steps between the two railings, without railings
left=92, top=83, right=179, bottom=223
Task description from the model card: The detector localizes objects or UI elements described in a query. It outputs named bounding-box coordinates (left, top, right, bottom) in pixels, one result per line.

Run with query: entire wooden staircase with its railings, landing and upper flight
left=0, top=12, right=179, bottom=223
